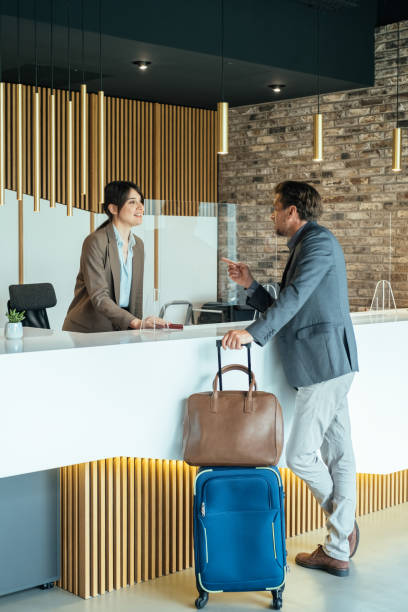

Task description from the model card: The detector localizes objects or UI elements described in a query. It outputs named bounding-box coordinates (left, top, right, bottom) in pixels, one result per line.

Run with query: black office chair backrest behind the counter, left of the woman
left=7, top=283, right=57, bottom=329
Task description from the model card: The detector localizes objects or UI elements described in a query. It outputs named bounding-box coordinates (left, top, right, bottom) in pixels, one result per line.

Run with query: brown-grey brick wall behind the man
left=219, top=21, right=408, bottom=311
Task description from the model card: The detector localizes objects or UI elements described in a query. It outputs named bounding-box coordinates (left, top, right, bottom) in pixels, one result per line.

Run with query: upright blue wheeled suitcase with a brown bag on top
left=193, top=467, right=286, bottom=610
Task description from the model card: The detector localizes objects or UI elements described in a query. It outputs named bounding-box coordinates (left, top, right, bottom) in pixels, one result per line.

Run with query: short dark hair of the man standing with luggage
left=275, top=181, right=323, bottom=221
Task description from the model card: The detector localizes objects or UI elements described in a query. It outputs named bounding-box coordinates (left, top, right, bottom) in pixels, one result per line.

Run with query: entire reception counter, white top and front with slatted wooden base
left=0, top=310, right=408, bottom=597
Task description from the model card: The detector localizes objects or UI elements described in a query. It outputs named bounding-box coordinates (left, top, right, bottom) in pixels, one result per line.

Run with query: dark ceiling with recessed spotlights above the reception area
left=1, top=0, right=408, bottom=108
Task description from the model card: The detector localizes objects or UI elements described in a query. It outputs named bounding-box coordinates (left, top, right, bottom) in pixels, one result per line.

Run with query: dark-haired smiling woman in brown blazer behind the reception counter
left=62, top=181, right=165, bottom=332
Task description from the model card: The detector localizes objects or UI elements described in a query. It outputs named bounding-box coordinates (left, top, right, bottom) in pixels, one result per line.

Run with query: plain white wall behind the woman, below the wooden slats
left=0, top=191, right=217, bottom=329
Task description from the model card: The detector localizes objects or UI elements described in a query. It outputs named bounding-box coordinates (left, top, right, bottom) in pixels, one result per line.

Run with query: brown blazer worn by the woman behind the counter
left=62, top=223, right=144, bottom=332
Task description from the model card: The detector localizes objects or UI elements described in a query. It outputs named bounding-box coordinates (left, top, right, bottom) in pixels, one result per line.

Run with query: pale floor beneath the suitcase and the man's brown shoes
left=0, top=504, right=408, bottom=612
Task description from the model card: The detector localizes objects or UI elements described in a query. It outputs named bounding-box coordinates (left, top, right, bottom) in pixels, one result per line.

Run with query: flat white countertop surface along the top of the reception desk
left=0, top=309, right=408, bottom=356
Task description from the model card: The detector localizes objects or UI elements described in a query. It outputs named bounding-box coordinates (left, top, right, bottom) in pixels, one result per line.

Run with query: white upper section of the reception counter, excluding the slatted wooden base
left=0, top=310, right=408, bottom=477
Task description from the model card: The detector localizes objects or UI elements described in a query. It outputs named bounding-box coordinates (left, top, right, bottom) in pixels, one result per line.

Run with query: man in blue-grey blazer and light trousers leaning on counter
left=222, top=181, right=359, bottom=576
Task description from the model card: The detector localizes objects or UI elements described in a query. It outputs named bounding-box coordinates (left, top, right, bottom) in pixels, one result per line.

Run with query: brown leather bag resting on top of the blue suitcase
left=183, top=347, right=283, bottom=466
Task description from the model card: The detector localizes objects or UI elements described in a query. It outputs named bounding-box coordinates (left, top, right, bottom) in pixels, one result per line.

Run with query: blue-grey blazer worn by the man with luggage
left=247, top=222, right=358, bottom=387
